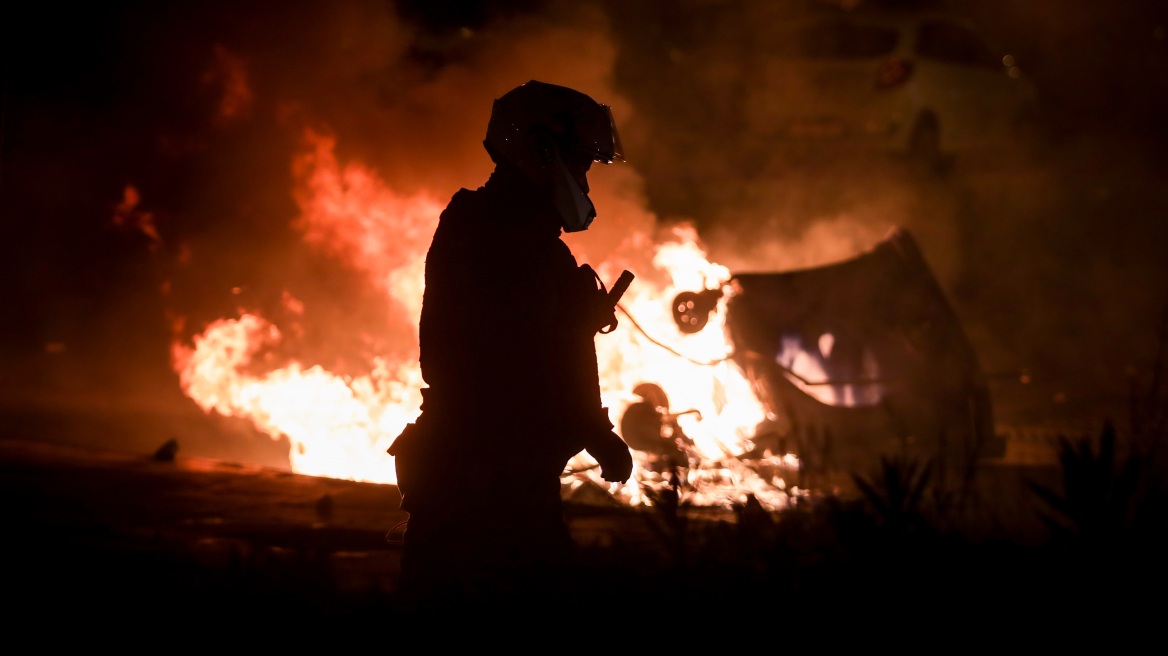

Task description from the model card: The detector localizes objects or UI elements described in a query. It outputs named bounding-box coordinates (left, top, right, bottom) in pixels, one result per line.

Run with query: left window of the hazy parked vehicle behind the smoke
left=777, top=20, right=898, bottom=60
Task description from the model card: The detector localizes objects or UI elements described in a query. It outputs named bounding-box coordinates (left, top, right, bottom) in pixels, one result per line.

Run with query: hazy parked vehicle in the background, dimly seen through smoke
left=744, top=3, right=1037, bottom=169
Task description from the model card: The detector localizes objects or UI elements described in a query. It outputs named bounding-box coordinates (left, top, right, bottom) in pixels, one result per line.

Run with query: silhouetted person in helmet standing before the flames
left=389, top=81, right=633, bottom=608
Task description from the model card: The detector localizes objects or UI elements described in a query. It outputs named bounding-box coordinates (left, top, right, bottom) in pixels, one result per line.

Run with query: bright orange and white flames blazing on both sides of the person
left=173, top=123, right=799, bottom=509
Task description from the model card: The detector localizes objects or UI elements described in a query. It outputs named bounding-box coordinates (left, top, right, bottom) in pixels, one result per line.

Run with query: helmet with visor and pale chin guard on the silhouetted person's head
left=482, top=79, right=624, bottom=232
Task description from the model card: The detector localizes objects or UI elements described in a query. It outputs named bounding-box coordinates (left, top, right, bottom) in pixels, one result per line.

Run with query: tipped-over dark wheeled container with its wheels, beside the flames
left=621, top=224, right=1000, bottom=486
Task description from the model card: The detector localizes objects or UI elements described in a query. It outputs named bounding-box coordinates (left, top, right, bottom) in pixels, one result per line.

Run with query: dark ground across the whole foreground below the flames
left=0, top=417, right=1168, bottom=641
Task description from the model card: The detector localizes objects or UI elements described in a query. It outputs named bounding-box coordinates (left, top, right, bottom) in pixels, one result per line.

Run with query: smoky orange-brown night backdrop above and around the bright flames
left=0, top=0, right=1168, bottom=460
